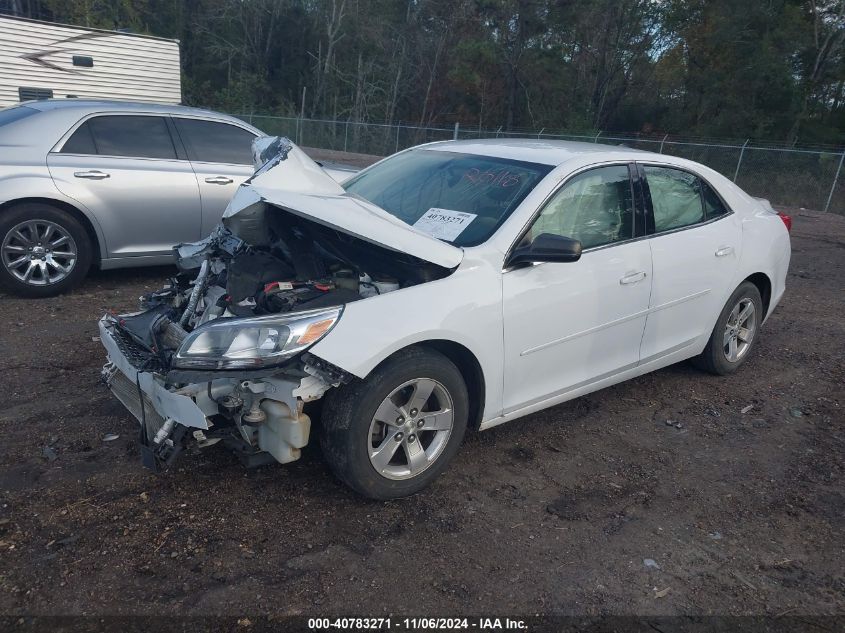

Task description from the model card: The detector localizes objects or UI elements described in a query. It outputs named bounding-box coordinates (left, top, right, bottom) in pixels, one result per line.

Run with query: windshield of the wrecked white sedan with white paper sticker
left=343, top=149, right=552, bottom=246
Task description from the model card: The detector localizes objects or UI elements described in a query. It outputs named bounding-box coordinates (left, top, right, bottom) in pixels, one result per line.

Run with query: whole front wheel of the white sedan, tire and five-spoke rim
left=320, top=347, right=469, bottom=500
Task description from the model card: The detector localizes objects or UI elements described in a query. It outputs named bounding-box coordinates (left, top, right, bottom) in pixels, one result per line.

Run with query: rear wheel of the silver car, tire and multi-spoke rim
left=0, top=203, right=92, bottom=297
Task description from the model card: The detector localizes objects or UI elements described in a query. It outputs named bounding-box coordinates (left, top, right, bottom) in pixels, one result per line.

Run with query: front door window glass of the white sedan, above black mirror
left=527, top=165, right=634, bottom=248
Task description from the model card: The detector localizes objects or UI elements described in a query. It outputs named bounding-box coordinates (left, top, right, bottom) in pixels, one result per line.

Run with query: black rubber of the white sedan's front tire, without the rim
left=320, top=347, right=469, bottom=501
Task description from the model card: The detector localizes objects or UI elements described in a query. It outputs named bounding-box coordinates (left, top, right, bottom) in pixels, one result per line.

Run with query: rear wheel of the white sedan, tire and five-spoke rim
left=694, top=281, right=763, bottom=376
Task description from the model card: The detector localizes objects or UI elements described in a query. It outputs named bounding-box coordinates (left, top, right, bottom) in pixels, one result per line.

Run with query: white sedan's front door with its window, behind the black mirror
left=502, top=165, right=652, bottom=413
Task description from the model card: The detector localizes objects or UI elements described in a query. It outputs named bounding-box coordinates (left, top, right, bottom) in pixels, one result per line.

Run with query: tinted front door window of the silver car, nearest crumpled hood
left=174, top=117, right=255, bottom=165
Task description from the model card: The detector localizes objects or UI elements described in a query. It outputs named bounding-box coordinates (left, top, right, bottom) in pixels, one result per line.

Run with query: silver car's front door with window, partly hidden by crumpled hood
left=173, top=117, right=255, bottom=235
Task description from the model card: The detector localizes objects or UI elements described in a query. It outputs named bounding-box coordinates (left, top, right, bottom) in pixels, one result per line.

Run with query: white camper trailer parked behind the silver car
left=0, top=15, right=182, bottom=107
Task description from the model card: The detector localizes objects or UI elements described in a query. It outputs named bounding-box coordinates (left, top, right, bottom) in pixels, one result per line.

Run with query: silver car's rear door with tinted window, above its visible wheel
left=47, top=114, right=201, bottom=257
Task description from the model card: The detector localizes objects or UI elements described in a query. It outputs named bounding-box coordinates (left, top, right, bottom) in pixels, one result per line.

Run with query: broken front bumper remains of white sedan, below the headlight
left=99, top=315, right=314, bottom=469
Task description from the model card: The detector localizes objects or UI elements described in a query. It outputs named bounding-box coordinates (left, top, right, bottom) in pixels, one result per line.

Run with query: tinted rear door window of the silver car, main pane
left=86, top=115, right=176, bottom=159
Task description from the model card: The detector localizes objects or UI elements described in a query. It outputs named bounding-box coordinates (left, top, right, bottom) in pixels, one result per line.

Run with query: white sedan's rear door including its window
left=640, top=165, right=742, bottom=362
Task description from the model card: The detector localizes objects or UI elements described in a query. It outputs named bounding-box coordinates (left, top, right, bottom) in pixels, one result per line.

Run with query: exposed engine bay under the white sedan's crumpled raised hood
left=118, top=203, right=443, bottom=368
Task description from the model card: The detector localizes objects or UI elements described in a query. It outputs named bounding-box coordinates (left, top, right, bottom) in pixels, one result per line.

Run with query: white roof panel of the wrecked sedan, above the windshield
left=424, top=138, right=653, bottom=167
